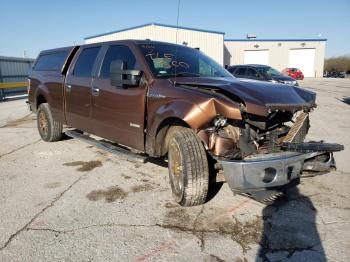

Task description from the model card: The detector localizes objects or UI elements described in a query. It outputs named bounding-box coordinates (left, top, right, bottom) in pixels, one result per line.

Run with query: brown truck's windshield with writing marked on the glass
left=139, top=43, right=232, bottom=78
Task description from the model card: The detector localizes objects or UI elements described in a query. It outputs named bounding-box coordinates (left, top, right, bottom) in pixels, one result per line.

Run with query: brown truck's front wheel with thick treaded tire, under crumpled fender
left=167, top=127, right=209, bottom=206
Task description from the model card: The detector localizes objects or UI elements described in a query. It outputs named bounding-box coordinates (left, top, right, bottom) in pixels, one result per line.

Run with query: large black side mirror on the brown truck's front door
left=109, top=60, right=142, bottom=87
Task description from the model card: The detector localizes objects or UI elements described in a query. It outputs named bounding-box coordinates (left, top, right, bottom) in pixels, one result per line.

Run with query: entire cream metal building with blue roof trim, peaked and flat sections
left=85, top=23, right=327, bottom=77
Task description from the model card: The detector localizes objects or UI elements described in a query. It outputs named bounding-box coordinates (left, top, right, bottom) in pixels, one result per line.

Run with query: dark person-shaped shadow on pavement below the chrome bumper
left=257, top=187, right=326, bottom=261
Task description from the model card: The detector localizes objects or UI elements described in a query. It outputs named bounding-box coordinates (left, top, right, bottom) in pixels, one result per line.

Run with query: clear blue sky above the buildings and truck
left=0, top=0, right=350, bottom=57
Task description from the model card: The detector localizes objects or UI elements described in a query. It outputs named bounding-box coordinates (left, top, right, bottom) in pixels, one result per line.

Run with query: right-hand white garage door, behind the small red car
left=289, top=48, right=315, bottom=77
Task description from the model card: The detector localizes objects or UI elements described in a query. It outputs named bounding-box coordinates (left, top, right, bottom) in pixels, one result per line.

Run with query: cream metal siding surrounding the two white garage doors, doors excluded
left=224, top=41, right=325, bottom=77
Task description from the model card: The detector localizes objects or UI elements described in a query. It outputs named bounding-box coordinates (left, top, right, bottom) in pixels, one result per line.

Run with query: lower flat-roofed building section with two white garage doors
left=224, top=39, right=327, bottom=77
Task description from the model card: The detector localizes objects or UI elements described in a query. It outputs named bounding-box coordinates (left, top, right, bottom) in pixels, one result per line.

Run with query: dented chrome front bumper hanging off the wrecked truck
left=221, top=143, right=344, bottom=192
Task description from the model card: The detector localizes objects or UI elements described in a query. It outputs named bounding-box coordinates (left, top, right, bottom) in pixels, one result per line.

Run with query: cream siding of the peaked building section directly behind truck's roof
left=85, top=25, right=224, bottom=65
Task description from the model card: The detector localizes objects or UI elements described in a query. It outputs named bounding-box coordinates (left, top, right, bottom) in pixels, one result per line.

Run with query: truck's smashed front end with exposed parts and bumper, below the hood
left=198, top=105, right=344, bottom=201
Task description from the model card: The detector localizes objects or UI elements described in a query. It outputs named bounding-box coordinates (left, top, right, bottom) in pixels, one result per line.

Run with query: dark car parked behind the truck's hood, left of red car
left=228, top=65, right=298, bottom=86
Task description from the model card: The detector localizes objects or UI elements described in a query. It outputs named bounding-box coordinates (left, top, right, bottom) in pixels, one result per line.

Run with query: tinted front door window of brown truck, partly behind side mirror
left=100, top=45, right=136, bottom=78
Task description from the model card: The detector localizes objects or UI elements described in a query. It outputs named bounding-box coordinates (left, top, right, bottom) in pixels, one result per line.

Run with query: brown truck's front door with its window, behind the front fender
left=91, top=44, right=147, bottom=151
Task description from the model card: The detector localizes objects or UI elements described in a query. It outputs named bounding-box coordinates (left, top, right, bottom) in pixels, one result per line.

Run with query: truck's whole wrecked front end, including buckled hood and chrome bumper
left=177, top=78, right=344, bottom=201
